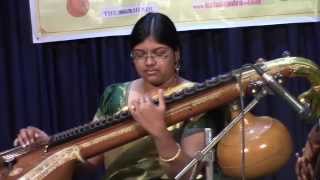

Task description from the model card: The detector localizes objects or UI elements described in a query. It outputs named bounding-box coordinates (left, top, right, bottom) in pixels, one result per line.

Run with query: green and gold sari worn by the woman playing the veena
left=95, top=82, right=228, bottom=180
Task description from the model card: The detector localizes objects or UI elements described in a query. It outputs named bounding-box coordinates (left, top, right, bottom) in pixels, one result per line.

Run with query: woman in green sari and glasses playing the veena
left=17, top=13, right=228, bottom=179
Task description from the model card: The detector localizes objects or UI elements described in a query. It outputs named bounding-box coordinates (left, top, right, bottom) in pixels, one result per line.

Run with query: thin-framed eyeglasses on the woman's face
left=130, top=47, right=171, bottom=61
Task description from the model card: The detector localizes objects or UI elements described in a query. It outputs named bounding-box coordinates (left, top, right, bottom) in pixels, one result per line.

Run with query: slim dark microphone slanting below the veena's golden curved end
left=251, top=65, right=312, bottom=120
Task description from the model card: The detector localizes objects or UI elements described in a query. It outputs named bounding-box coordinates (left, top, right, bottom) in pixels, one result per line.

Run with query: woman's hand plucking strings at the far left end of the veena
left=14, top=126, right=49, bottom=147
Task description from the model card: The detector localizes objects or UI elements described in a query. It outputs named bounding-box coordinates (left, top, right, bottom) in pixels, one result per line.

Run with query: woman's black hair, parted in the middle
left=129, top=13, right=180, bottom=51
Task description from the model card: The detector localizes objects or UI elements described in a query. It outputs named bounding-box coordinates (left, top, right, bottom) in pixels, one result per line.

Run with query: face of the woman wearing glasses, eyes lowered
left=131, top=37, right=180, bottom=86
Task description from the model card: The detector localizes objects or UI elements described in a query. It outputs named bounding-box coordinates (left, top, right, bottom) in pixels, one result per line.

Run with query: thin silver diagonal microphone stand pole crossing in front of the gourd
left=174, top=88, right=267, bottom=179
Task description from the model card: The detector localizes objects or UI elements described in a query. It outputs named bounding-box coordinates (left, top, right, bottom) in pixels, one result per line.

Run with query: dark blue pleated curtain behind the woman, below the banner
left=0, top=0, right=320, bottom=180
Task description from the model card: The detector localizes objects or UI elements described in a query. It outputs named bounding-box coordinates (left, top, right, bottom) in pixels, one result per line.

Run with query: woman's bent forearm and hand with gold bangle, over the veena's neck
left=129, top=90, right=204, bottom=177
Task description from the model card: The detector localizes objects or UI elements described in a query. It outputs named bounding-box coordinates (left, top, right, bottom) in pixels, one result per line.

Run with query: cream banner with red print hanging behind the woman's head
left=29, top=0, right=320, bottom=43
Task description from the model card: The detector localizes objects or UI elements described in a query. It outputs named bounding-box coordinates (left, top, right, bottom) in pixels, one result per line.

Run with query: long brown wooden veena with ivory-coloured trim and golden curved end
left=0, top=58, right=320, bottom=180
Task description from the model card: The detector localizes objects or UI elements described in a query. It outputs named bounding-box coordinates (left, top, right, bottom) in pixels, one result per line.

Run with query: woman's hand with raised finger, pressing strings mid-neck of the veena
left=130, top=90, right=167, bottom=137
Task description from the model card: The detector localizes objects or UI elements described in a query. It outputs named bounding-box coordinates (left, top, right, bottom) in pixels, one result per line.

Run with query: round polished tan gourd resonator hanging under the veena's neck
left=217, top=112, right=293, bottom=179
